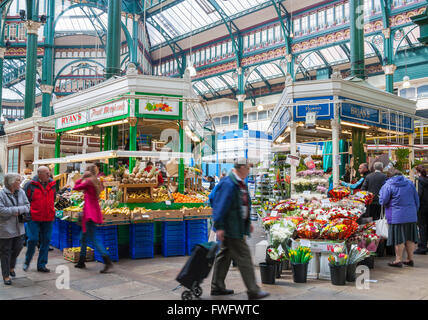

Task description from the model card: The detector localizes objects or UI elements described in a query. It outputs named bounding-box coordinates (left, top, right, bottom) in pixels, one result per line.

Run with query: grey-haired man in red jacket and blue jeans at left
left=23, top=166, right=56, bottom=272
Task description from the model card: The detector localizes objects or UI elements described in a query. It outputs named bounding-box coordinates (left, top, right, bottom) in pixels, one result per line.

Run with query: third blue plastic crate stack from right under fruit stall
left=129, top=223, right=155, bottom=259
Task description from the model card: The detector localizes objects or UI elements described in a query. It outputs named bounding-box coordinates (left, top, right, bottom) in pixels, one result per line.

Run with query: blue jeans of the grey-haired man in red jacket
left=25, top=221, right=53, bottom=269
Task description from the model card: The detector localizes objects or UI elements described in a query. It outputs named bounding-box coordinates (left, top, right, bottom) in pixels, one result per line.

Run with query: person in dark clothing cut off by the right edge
left=414, top=165, right=428, bottom=254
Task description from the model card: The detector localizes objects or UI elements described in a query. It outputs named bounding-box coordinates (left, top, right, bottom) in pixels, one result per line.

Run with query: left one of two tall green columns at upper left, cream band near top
left=24, top=0, right=41, bottom=119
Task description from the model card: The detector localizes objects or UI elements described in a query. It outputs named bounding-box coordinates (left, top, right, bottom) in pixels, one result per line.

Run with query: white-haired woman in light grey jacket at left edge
left=0, top=173, right=30, bottom=285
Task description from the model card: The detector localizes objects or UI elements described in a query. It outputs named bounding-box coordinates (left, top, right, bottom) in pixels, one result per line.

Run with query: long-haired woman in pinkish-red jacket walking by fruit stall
left=74, top=164, right=113, bottom=273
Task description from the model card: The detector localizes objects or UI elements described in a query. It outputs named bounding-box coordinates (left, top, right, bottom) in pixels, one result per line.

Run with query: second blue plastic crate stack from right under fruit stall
left=162, top=221, right=186, bottom=257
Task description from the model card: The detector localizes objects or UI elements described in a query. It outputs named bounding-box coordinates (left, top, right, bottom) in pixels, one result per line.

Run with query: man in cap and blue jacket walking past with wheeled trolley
left=211, top=160, right=269, bottom=299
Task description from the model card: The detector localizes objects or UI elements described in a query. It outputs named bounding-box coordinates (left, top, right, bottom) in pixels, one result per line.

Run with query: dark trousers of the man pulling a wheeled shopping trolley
left=211, top=238, right=260, bottom=294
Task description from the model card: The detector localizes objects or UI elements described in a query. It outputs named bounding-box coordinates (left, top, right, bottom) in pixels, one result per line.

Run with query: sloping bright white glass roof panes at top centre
left=148, top=0, right=270, bottom=46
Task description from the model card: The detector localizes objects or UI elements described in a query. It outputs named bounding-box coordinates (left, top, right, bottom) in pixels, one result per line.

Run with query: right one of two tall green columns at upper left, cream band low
left=40, top=0, right=55, bottom=117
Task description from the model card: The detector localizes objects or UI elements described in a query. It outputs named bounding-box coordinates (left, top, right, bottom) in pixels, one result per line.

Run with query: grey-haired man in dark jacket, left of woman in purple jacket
left=361, top=162, right=386, bottom=221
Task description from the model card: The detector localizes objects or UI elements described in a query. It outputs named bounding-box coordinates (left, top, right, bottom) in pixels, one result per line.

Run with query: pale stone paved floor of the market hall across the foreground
left=0, top=223, right=428, bottom=300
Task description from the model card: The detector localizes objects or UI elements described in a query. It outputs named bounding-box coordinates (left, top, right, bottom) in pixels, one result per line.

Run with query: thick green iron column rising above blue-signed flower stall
left=349, top=0, right=365, bottom=79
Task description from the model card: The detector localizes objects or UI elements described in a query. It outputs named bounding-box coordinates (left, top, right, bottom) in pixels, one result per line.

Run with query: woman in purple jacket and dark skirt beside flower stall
left=379, top=170, right=419, bottom=268
